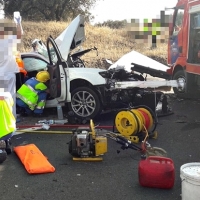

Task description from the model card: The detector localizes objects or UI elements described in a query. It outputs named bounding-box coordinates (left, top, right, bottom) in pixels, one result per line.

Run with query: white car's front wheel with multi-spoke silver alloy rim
left=69, top=87, right=101, bottom=119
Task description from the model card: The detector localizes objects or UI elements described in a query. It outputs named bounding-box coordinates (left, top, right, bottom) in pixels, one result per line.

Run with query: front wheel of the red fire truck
left=173, top=70, right=187, bottom=97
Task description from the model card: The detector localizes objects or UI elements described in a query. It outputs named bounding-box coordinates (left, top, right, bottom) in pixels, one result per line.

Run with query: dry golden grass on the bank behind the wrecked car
left=19, top=22, right=167, bottom=68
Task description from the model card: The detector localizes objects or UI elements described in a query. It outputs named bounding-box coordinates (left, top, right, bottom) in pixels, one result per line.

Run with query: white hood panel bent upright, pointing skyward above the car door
left=55, top=15, right=85, bottom=60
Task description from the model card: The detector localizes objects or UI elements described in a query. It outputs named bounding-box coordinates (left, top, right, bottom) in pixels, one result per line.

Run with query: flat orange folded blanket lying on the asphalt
left=14, top=144, right=55, bottom=174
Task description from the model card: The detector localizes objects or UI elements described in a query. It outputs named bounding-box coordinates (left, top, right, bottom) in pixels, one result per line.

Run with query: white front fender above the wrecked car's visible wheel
left=68, top=68, right=107, bottom=85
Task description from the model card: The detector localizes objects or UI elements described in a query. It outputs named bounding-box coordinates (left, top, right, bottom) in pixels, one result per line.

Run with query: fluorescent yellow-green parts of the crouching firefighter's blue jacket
left=17, top=83, right=47, bottom=110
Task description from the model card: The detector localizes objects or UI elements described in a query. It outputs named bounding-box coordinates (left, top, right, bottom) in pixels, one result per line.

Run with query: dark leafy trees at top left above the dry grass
left=0, top=0, right=98, bottom=21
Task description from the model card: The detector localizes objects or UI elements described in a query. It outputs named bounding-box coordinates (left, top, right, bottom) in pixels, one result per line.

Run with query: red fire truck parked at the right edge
left=167, top=0, right=200, bottom=97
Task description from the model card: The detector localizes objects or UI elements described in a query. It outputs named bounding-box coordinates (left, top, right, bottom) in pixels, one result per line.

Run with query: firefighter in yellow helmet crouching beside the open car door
left=16, top=71, right=50, bottom=117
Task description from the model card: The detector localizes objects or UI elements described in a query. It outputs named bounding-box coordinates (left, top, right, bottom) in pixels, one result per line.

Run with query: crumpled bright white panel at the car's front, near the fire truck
left=109, top=51, right=169, bottom=72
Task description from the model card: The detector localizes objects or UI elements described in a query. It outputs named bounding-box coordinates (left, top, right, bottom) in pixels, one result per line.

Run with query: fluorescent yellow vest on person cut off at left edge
left=0, top=98, right=16, bottom=138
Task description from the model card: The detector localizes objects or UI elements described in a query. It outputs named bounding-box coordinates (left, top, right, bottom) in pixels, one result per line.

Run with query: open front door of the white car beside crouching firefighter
left=47, top=36, right=70, bottom=102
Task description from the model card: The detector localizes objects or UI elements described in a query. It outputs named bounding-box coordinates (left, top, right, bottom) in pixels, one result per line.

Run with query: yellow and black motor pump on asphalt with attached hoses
left=69, top=120, right=167, bottom=161
